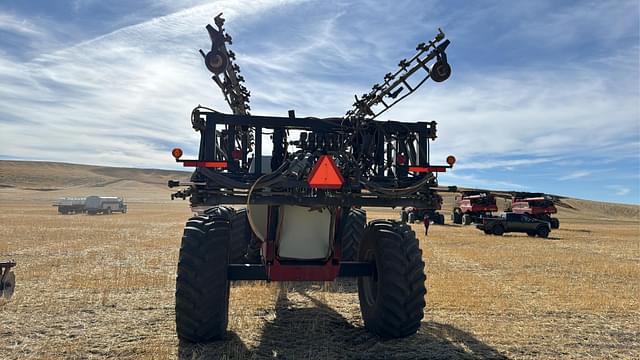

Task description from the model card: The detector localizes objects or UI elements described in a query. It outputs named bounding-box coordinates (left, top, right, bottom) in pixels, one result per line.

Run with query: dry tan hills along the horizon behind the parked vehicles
left=0, top=160, right=640, bottom=221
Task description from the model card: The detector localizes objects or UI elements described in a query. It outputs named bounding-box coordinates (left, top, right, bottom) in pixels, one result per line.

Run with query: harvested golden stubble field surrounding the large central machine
left=0, top=162, right=640, bottom=359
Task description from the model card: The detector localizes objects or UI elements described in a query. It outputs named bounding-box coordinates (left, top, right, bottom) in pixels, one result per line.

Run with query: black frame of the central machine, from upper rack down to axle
left=169, top=109, right=453, bottom=281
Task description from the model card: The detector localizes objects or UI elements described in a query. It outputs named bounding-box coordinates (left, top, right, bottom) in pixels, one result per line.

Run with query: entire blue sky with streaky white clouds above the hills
left=0, top=0, right=640, bottom=204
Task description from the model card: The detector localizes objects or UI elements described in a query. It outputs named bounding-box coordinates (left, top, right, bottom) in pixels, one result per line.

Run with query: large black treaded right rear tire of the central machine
left=358, top=220, right=427, bottom=338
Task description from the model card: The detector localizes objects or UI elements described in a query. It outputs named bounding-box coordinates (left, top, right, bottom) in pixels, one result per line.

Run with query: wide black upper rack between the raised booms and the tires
left=169, top=110, right=452, bottom=209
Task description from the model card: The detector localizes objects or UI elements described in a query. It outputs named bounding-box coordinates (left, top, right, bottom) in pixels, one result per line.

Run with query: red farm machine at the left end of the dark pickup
left=451, top=191, right=498, bottom=225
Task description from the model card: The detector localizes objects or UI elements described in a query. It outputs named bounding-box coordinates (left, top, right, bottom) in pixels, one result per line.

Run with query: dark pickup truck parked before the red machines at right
left=476, top=213, right=551, bottom=238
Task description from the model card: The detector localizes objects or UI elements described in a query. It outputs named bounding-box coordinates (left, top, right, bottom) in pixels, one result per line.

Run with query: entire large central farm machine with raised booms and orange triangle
left=169, top=15, right=455, bottom=342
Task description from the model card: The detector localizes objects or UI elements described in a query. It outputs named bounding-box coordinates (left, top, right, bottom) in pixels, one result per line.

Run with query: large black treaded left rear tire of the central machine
left=176, top=215, right=230, bottom=342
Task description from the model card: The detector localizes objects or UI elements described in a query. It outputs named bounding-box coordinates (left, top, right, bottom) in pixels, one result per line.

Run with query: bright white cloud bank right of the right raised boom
left=388, top=48, right=640, bottom=165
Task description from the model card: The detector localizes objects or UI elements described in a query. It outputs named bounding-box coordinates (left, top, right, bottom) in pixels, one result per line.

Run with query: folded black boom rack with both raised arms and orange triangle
left=169, top=14, right=455, bottom=209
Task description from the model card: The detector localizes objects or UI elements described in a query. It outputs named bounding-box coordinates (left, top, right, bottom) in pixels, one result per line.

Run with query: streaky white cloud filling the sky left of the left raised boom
left=0, top=1, right=302, bottom=167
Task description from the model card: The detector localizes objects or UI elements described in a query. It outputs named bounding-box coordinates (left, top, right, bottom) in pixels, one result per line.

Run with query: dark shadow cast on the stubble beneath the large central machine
left=179, top=286, right=507, bottom=359
